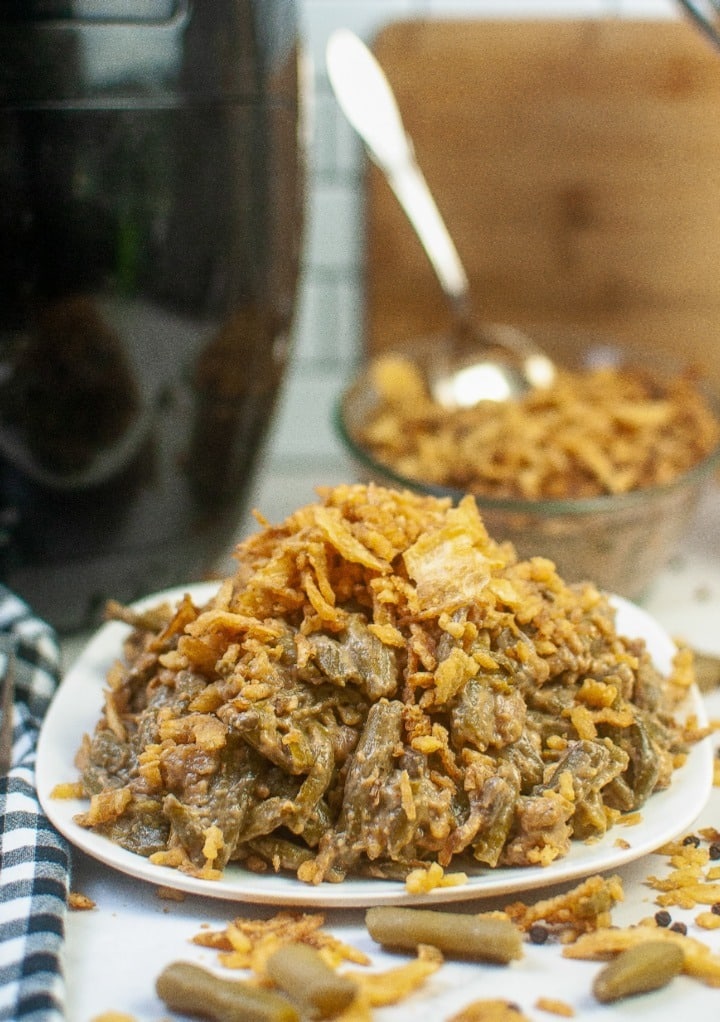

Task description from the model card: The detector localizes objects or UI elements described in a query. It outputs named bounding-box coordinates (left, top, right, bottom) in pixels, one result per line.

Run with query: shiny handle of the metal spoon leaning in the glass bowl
left=326, top=29, right=470, bottom=321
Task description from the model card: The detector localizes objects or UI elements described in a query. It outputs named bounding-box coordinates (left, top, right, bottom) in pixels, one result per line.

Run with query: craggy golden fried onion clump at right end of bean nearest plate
left=506, top=876, right=624, bottom=943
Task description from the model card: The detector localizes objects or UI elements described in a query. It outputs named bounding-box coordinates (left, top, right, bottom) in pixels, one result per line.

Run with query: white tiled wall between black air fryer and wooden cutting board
left=251, top=0, right=681, bottom=531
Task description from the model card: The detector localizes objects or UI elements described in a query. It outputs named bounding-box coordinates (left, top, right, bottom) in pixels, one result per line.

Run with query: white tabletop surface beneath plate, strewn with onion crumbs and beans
left=60, top=482, right=720, bottom=1022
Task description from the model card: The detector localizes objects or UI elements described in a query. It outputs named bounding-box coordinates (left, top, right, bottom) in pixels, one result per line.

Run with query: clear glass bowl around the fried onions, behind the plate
left=335, top=330, right=720, bottom=600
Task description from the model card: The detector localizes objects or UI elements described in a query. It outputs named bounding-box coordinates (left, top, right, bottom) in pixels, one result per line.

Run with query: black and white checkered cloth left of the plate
left=0, top=586, right=69, bottom=1022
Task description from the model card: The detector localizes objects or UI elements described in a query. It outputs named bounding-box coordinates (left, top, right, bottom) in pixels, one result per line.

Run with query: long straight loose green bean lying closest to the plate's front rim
left=365, top=907, right=523, bottom=965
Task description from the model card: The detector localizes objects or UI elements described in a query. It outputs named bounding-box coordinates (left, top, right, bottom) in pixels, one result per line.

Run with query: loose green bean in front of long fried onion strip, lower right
left=592, top=940, right=684, bottom=1004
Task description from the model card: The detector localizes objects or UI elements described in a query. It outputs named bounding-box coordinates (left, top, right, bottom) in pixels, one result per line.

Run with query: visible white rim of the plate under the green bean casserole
left=36, top=583, right=713, bottom=909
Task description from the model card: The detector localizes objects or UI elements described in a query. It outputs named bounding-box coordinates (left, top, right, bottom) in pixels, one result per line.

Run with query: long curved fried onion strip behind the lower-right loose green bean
left=563, top=926, right=720, bottom=986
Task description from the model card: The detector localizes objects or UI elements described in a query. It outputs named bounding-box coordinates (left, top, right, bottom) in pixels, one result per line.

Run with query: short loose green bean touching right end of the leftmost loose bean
left=266, top=944, right=357, bottom=1019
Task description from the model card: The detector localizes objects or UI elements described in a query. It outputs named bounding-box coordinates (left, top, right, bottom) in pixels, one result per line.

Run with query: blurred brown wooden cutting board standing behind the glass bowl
left=366, top=18, right=720, bottom=379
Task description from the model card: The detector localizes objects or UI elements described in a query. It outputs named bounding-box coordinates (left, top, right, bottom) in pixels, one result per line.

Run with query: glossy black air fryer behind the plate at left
left=0, top=0, right=302, bottom=631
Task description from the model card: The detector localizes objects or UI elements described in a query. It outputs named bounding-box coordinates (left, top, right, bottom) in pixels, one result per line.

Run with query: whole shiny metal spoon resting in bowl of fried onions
left=326, top=29, right=555, bottom=408
